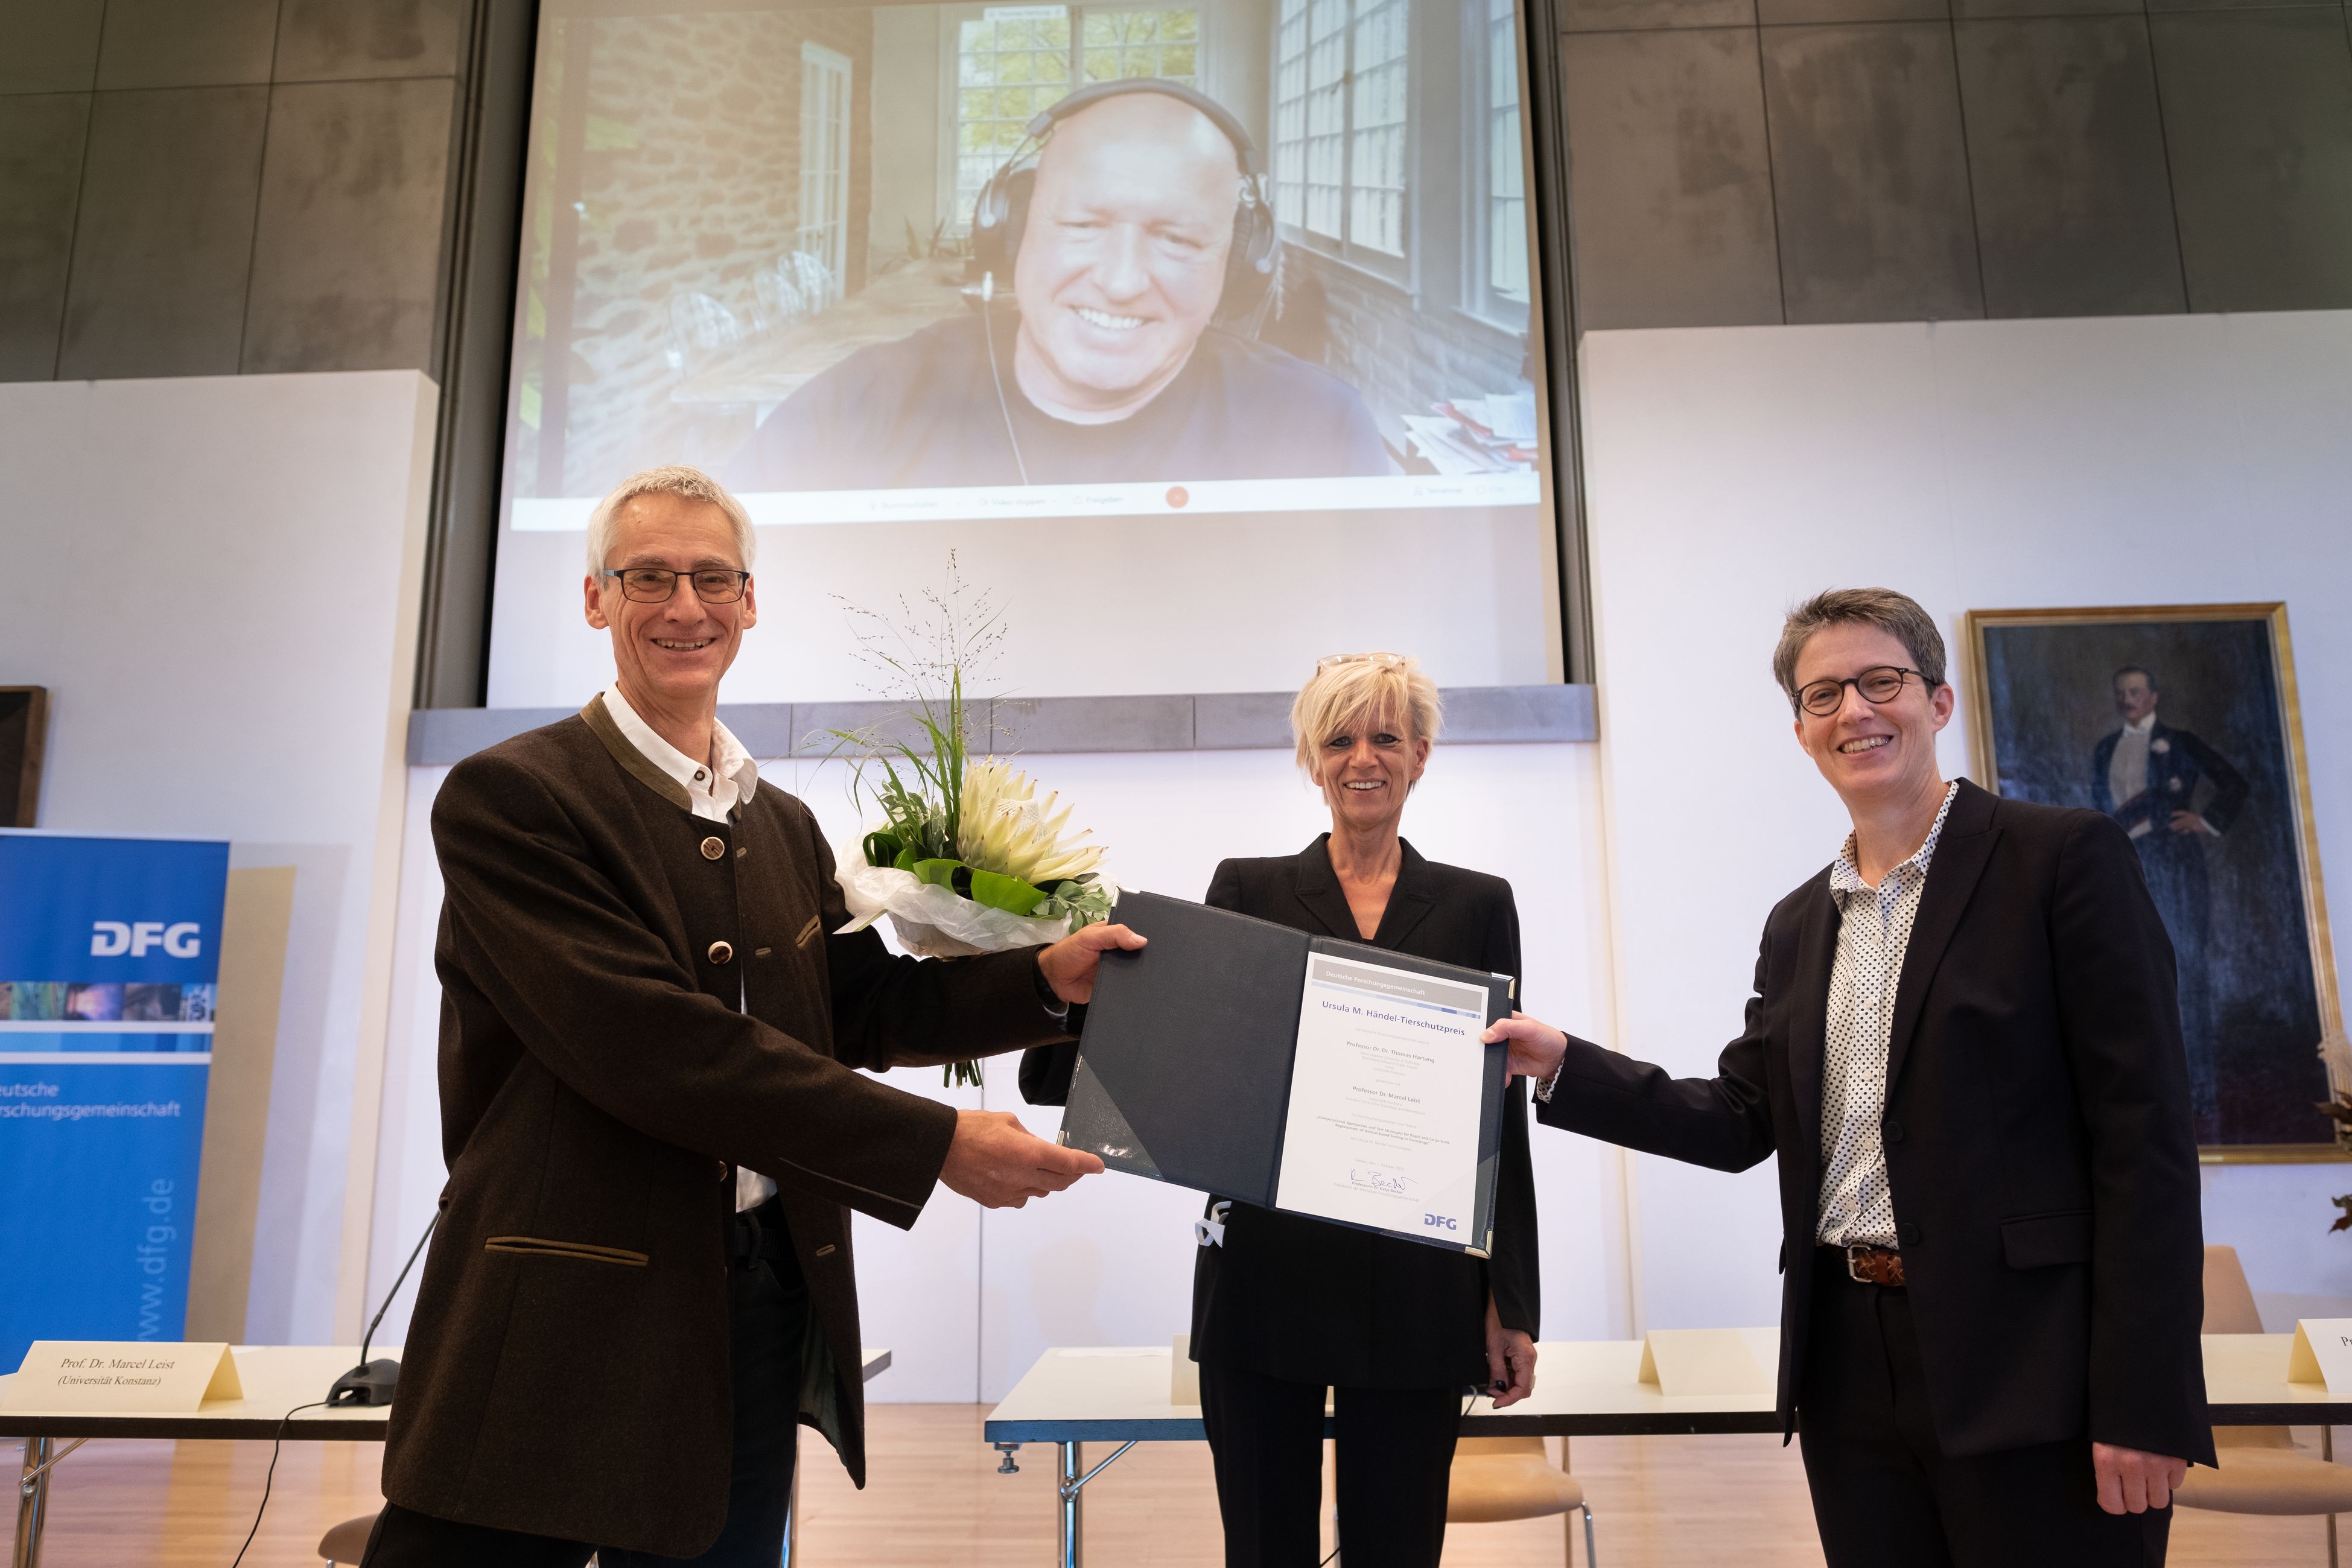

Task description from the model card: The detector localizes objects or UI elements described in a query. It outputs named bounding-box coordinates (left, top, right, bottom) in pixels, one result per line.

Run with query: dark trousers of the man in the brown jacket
left=360, top=1199, right=809, bottom=1568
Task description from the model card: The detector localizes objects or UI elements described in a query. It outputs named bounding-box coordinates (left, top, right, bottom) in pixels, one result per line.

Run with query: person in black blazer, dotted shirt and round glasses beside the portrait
left=1489, top=588, right=2213, bottom=1568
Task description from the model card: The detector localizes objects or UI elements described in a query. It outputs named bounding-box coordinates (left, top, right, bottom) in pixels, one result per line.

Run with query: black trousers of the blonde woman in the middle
left=1200, top=1363, right=1463, bottom=1568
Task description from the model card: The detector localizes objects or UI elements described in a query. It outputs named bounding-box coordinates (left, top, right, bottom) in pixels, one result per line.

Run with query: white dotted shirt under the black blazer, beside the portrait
left=1816, top=783, right=1959, bottom=1246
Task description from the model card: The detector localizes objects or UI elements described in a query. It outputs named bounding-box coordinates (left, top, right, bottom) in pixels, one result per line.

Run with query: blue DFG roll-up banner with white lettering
left=0, top=832, right=228, bottom=1371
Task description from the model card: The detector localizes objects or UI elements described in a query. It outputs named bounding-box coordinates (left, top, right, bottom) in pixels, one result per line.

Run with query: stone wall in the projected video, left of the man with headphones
left=548, top=10, right=872, bottom=496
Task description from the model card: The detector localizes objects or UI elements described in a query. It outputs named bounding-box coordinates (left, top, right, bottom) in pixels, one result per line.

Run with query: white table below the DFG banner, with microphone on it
left=0, top=1345, right=889, bottom=1568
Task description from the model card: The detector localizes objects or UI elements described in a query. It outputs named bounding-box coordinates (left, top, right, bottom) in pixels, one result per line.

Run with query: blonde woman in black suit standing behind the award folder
left=1021, top=653, right=1538, bottom=1568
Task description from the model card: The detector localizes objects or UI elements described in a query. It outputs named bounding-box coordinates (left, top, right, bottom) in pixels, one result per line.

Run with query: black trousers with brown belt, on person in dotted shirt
left=1797, top=1248, right=2173, bottom=1568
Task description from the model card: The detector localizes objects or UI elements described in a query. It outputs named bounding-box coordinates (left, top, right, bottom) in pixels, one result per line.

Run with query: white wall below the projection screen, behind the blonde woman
left=369, top=743, right=1630, bottom=1401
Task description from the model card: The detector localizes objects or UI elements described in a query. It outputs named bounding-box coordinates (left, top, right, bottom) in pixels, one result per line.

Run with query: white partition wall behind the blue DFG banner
left=0, top=372, right=437, bottom=1342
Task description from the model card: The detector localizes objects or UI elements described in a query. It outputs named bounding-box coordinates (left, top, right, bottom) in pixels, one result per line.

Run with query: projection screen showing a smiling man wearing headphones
left=489, top=0, right=1559, bottom=705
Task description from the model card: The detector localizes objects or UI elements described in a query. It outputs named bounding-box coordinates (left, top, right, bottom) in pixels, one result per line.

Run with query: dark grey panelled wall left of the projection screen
left=0, top=0, right=468, bottom=381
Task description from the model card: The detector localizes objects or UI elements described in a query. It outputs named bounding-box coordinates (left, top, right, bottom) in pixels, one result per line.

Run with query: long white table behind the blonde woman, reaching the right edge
left=983, top=1328, right=2352, bottom=1568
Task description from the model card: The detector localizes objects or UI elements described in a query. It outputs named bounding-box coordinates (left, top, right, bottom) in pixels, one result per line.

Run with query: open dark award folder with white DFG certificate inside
left=1061, top=894, right=1514, bottom=1258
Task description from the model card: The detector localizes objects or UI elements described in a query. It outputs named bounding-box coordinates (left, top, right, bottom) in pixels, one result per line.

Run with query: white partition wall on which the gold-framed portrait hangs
left=1583, top=313, right=2352, bottom=1328
